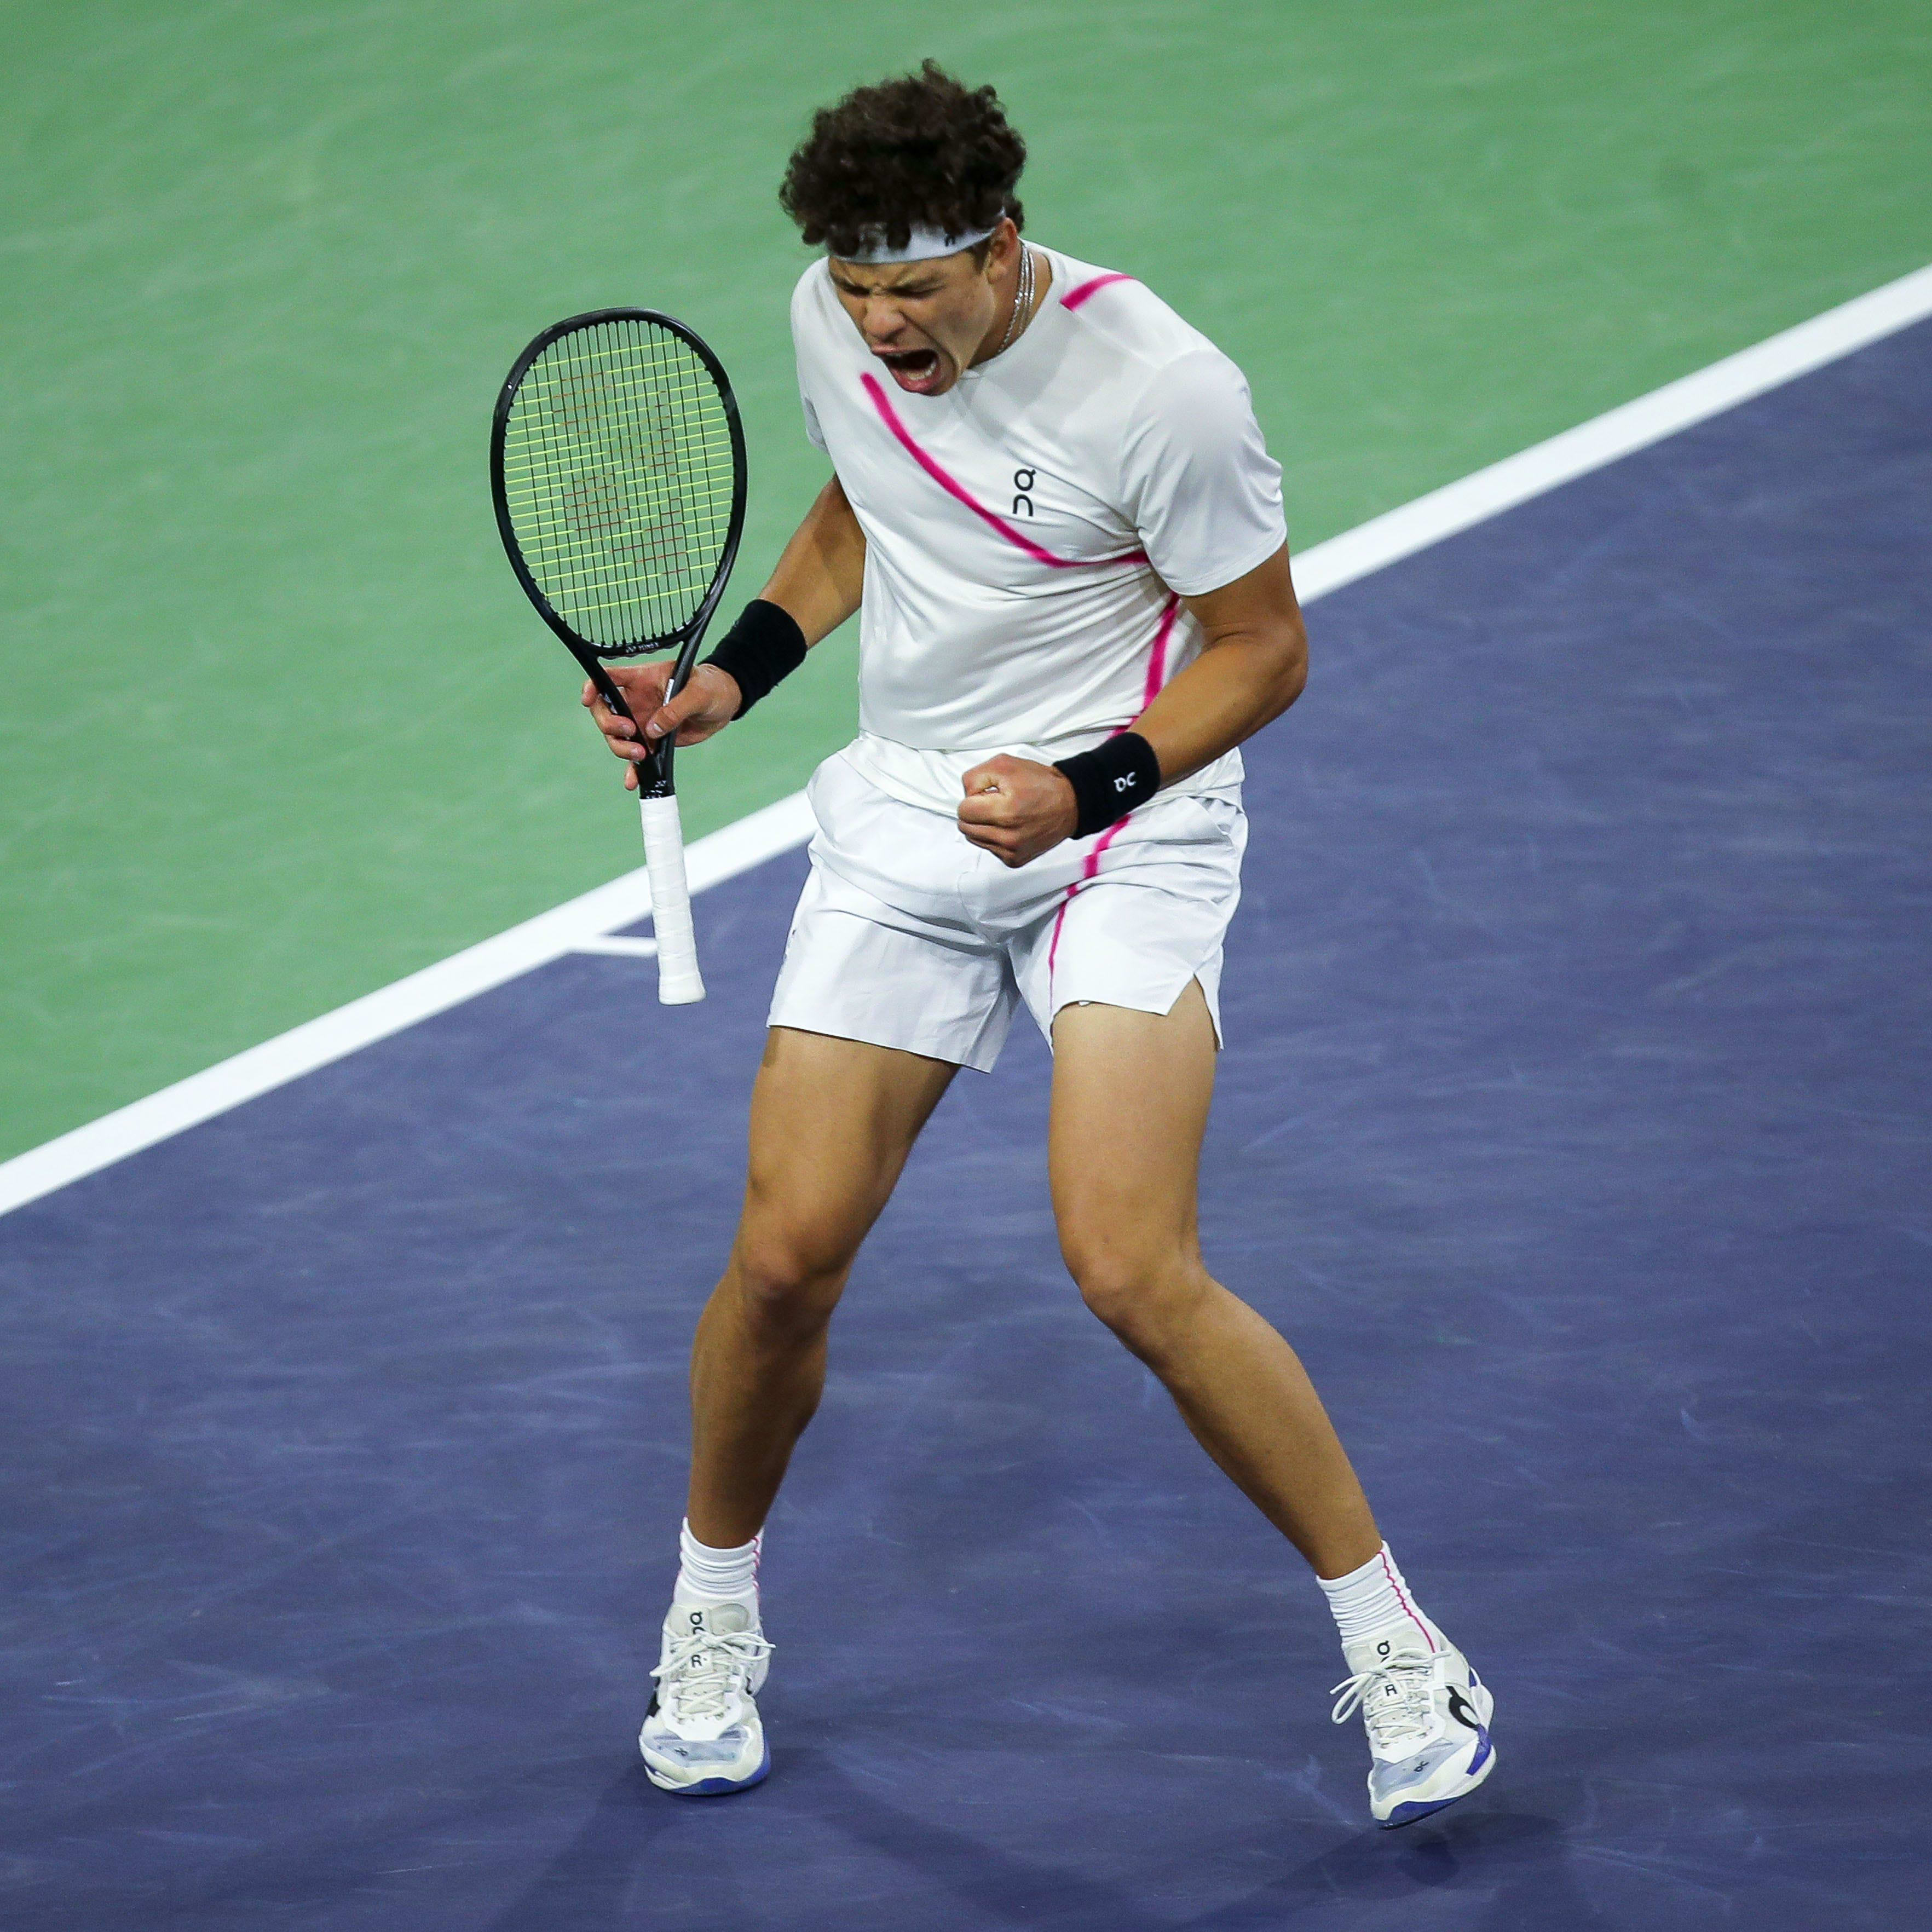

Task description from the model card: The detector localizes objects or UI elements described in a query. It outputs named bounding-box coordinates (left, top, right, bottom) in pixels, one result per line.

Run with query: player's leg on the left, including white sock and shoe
left=638, top=1026, right=954, bottom=1797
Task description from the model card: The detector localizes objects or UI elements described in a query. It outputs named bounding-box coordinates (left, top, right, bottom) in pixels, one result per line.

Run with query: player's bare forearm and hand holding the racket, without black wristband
left=584, top=477, right=866, bottom=786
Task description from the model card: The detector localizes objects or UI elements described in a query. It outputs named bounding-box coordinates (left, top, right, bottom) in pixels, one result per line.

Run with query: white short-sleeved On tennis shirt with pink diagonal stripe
left=792, top=249, right=1287, bottom=814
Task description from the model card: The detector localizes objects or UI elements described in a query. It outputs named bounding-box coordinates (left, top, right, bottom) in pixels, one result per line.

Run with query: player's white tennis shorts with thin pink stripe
left=769, top=753, right=1248, bottom=1072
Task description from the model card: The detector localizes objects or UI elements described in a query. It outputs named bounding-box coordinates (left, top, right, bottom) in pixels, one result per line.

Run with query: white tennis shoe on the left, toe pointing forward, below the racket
left=638, top=1604, right=771, bottom=1798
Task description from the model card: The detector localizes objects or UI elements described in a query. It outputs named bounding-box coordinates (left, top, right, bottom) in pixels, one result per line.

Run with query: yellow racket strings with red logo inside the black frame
left=503, top=319, right=736, bottom=655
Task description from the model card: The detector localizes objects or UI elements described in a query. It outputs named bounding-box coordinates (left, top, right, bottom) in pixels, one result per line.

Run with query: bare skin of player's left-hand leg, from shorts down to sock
left=688, top=1026, right=958, bottom=1548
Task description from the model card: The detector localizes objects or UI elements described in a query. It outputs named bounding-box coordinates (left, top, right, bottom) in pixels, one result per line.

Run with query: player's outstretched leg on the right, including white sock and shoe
left=1051, top=982, right=1495, bottom=1826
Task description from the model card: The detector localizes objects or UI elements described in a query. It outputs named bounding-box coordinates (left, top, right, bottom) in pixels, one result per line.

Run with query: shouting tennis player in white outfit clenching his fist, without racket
left=585, top=62, right=1495, bottom=1826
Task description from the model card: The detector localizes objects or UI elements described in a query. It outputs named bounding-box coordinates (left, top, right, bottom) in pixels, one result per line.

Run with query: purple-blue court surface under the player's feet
left=0, top=313, right=1932, bottom=1932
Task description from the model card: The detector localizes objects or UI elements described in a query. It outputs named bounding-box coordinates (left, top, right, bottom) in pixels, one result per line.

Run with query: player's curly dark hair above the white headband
left=778, top=60, right=1026, bottom=255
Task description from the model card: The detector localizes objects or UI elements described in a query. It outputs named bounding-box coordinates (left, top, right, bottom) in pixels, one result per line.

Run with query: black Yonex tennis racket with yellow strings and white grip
left=491, top=309, right=746, bottom=1007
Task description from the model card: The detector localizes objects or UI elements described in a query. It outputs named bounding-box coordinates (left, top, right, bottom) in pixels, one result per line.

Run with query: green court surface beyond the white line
left=0, top=0, right=1932, bottom=1155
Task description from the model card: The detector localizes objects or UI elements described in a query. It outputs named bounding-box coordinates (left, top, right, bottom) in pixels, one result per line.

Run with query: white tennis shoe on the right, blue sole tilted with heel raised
left=1333, top=1623, right=1495, bottom=1827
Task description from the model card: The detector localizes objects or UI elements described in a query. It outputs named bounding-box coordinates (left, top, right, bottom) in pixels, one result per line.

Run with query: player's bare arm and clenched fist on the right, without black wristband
left=958, top=545, right=1308, bottom=866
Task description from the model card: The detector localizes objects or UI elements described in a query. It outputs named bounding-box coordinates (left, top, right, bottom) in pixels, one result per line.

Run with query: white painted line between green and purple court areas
left=0, top=267, right=1932, bottom=1213
